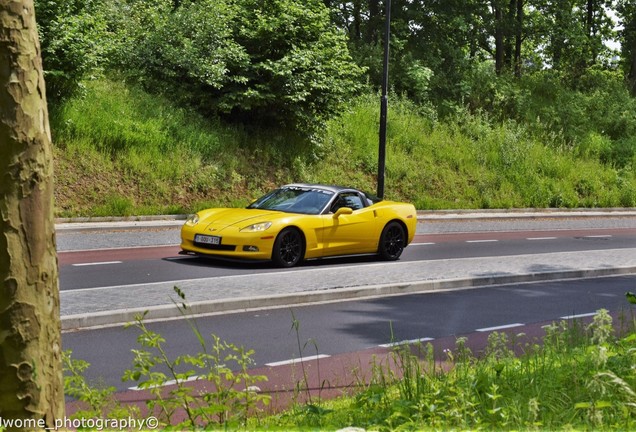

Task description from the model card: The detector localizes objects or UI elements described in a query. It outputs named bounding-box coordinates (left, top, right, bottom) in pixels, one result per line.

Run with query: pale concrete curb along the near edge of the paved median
left=61, top=266, right=636, bottom=331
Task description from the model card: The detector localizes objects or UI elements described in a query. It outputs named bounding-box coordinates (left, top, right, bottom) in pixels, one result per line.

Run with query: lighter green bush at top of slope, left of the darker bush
left=115, top=0, right=242, bottom=103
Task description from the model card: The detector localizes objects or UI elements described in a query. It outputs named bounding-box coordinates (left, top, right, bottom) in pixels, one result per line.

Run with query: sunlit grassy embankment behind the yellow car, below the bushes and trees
left=51, top=80, right=636, bottom=217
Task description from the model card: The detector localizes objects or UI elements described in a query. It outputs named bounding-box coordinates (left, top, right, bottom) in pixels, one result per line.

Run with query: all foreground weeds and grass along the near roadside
left=65, top=298, right=636, bottom=430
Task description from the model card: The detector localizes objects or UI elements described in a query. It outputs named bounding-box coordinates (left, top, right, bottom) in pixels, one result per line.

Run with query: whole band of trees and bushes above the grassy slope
left=36, top=0, right=636, bottom=162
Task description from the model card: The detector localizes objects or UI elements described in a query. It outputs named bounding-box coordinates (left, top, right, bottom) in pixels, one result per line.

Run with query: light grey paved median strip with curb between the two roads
left=61, top=245, right=636, bottom=330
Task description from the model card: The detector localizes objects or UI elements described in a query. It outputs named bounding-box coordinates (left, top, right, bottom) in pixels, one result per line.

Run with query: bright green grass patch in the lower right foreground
left=251, top=310, right=636, bottom=431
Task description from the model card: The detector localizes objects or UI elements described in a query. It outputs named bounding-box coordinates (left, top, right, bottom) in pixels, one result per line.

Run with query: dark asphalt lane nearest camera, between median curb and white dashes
left=62, top=276, right=636, bottom=390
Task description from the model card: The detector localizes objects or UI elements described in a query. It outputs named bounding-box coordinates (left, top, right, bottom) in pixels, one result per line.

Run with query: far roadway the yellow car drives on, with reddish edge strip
left=58, top=217, right=636, bottom=290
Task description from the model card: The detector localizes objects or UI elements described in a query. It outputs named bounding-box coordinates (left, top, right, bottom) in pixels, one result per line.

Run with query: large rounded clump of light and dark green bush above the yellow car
left=110, top=0, right=362, bottom=134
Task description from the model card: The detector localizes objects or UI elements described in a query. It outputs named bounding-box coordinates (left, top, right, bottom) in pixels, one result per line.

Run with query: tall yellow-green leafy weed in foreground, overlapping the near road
left=123, top=287, right=270, bottom=428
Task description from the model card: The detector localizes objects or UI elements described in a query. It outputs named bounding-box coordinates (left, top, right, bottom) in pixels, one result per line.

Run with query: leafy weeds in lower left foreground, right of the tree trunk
left=62, top=286, right=271, bottom=430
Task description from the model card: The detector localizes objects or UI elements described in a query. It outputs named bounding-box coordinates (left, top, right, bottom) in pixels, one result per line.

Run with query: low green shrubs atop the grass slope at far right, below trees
left=456, top=63, right=636, bottom=167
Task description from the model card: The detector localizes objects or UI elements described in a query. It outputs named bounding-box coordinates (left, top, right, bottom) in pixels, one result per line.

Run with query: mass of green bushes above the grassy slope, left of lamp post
left=36, top=0, right=363, bottom=132
